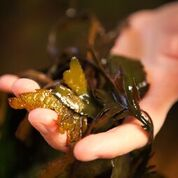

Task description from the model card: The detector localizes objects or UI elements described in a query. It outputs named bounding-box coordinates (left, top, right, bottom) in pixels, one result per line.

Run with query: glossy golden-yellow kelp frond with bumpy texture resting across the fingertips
left=9, top=59, right=90, bottom=143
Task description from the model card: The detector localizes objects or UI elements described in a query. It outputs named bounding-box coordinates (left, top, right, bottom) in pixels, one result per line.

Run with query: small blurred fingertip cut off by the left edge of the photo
left=0, top=74, right=18, bottom=93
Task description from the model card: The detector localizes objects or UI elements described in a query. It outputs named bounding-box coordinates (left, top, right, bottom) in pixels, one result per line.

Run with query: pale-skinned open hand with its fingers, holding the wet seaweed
left=0, top=3, right=178, bottom=161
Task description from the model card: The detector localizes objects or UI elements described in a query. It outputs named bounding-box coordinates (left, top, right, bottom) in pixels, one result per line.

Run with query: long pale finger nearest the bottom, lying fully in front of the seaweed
left=74, top=119, right=147, bottom=161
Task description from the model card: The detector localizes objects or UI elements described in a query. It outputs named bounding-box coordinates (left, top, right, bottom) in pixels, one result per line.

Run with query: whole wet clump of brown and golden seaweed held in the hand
left=2, top=7, right=163, bottom=178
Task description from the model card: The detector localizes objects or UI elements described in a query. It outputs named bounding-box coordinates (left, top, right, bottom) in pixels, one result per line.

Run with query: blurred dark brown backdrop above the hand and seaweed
left=0, top=0, right=176, bottom=74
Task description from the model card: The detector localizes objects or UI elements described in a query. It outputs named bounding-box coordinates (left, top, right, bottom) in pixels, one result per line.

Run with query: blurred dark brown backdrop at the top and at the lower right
left=0, top=0, right=178, bottom=178
